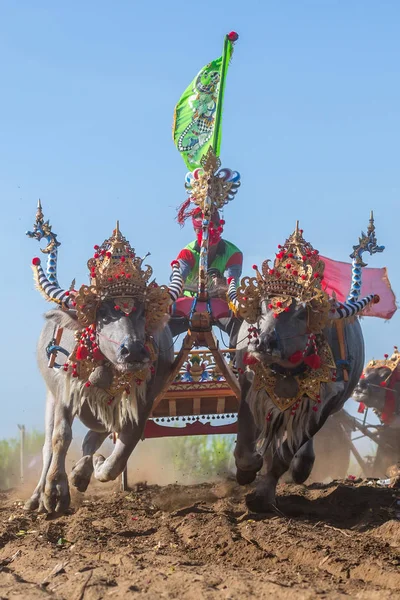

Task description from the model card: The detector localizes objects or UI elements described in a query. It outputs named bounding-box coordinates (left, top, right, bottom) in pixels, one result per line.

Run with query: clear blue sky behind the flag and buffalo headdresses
left=0, top=0, right=400, bottom=437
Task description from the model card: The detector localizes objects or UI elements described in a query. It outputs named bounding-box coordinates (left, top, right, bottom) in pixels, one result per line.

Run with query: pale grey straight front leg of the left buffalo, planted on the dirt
left=43, top=402, right=73, bottom=514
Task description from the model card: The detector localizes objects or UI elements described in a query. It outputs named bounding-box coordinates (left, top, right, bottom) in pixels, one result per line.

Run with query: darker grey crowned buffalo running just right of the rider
left=229, top=228, right=378, bottom=512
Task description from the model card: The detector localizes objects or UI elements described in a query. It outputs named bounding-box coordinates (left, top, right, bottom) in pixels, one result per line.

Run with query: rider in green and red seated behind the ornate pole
left=169, top=207, right=243, bottom=348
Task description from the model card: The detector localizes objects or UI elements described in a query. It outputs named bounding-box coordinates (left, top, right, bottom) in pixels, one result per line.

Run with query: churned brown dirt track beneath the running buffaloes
left=0, top=482, right=400, bottom=600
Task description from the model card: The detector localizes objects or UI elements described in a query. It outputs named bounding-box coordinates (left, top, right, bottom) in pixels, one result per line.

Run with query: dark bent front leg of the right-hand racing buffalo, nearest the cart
left=234, top=381, right=263, bottom=485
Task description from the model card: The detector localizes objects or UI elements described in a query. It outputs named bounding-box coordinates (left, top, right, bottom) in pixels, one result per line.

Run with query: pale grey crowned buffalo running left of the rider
left=26, top=227, right=183, bottom=513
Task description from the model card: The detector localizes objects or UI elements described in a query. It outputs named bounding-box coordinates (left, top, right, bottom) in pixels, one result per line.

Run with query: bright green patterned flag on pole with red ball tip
left=173, top=32, right=238, bottom=171
